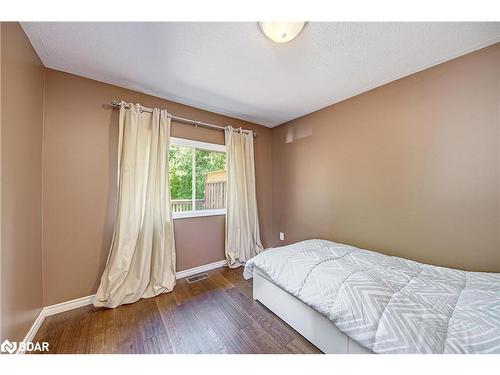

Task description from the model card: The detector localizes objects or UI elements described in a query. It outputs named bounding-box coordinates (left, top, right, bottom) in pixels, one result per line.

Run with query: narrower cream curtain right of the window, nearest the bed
left=225, top=126, right=263, bottom=268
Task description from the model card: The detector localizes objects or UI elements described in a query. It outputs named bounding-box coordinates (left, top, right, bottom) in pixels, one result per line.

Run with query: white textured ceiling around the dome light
left=22, top=22, right=500, bottom=127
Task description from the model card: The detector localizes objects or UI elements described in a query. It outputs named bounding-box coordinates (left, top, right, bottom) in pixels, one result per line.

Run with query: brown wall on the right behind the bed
left=272, top=44, right=500, bottom=272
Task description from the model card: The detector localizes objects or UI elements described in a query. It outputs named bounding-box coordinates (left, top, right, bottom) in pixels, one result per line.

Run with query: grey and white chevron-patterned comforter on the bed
left=244, top=240, right=500, bottom=353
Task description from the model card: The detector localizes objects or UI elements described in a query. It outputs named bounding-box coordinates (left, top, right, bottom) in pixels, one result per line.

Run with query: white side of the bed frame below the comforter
left=253, top=267, right=372, bottom=354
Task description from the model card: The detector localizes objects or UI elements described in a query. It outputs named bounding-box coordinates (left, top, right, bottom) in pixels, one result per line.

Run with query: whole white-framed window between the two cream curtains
left=168, top=137, right=226, bottom=219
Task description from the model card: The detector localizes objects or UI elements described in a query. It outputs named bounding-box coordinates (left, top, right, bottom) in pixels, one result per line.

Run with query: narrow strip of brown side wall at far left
left=0, top=23, right=45, bottom=341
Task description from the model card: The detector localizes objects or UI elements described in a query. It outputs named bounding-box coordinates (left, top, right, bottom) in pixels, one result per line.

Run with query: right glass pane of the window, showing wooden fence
left=195, top=150, right=226, bottom=210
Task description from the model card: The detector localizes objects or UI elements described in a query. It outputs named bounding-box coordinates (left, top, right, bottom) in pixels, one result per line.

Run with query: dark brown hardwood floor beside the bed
left=34, top=268, right=320, bottom=353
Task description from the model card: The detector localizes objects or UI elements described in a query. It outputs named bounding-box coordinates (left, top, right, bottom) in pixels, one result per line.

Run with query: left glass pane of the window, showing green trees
left=168, top=145, right=194, bottom=212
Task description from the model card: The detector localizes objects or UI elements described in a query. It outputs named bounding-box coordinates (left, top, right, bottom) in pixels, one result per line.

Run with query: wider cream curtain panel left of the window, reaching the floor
left=94, top=103, right=175, bottom=307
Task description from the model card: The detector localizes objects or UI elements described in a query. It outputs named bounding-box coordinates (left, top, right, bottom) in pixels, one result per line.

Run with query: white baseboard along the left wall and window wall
left=16, top=260, right=226, bottom=354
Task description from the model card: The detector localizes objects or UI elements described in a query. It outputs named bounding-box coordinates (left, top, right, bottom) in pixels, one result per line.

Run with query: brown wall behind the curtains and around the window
left=43, top=69, right=272, bottom=305
